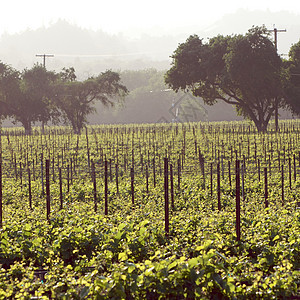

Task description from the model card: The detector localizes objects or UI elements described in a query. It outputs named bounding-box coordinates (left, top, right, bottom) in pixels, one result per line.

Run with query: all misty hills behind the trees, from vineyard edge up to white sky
left=0, top=9, right=300, bottom=126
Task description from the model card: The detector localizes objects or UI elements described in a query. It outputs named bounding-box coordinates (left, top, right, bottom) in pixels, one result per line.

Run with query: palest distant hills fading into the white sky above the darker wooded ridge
left=0, top=9, right=300, bottom=77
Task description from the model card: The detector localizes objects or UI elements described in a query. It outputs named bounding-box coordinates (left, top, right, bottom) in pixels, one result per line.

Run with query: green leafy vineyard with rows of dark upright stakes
left=0, top=120, right=300, bottom=299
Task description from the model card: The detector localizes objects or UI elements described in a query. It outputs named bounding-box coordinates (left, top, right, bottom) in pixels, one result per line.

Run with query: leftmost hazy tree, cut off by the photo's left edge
left=0, top=63, right=56, bottom=133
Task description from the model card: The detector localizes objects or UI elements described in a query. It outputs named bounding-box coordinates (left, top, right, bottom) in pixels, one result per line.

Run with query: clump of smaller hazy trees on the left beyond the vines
left=0, top=62, right=128, bottom=134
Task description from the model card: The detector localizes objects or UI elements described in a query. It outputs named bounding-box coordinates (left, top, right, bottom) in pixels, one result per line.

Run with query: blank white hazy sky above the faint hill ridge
left=0, top=0, right=300, bottom=34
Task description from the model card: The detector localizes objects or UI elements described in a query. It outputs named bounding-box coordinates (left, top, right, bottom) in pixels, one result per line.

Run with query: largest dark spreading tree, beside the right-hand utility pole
left=165, top=27, right=284, bottom=131
